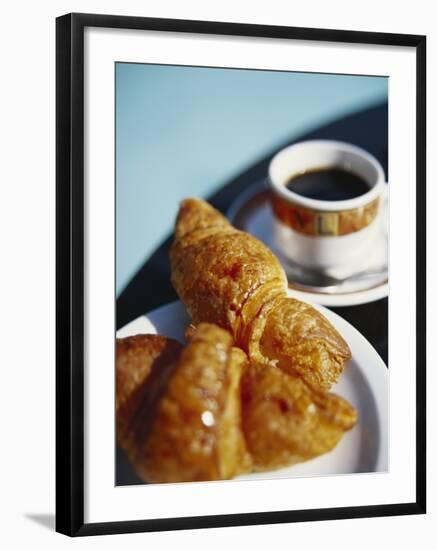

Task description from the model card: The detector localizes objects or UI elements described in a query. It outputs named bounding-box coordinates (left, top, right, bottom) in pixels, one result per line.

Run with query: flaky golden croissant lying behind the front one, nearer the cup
left=170, top=199, right=351, bottom=390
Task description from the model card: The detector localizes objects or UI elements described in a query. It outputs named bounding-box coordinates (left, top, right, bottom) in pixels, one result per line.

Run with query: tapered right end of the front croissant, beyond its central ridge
left=242, top=364, right=357, bottom=471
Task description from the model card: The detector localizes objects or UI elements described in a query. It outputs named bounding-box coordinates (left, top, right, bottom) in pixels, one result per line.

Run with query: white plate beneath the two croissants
left=117, top=302, right=388, bottom=479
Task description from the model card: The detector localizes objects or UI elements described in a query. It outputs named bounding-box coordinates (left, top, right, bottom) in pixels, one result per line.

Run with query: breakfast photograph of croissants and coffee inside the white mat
left=114, top=61, right=389, bottom=486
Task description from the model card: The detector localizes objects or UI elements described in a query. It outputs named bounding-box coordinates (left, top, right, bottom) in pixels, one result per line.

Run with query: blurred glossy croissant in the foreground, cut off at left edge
left=116, top=323, right=357, bottom=483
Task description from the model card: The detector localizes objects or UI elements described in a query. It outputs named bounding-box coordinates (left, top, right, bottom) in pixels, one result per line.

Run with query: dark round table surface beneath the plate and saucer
left=117, top=104, right=388, bottom=364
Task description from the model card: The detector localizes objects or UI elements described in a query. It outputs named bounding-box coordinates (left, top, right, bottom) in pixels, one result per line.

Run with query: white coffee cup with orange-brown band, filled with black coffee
left=268, top=140, right=386, bottom=270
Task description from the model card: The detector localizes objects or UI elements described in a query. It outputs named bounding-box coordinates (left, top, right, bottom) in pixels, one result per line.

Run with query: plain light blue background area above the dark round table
left=116, top=63, right=388, bottom=295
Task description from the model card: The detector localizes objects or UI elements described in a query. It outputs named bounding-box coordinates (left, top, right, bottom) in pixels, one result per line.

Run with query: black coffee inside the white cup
left=286, top=168, right=370, bottom=201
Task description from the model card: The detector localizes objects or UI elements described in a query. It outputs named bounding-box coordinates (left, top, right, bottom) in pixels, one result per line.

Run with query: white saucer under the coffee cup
left=227, top=180, right=388, bottom=306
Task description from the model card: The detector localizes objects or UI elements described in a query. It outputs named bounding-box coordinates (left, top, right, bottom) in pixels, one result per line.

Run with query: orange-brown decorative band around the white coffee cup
left=272, top=194, right=380, bottom=237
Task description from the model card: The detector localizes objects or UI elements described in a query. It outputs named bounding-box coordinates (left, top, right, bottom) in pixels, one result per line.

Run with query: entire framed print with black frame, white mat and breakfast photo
left=56, top=14, right=426, bottom=536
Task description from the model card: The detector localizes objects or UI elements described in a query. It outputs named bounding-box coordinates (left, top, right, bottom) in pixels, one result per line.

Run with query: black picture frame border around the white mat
left=56, top=13, right=426, bottom=536
